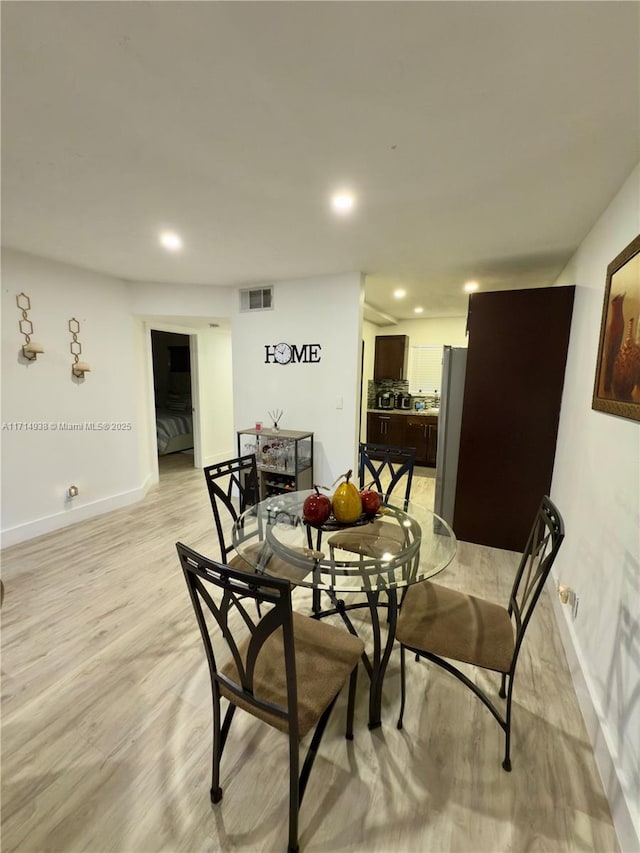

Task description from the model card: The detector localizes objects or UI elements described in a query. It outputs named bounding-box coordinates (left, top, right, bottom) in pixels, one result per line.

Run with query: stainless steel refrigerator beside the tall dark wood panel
left=434, top=346, right=467, bottom=527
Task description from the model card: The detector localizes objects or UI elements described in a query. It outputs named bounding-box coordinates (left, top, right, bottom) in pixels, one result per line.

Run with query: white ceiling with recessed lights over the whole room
left=1, top=0, right=640, bottom=318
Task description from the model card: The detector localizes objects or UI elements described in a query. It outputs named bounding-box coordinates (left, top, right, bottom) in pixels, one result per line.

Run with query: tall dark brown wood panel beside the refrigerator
left=453, top=287, right=574, bottom=551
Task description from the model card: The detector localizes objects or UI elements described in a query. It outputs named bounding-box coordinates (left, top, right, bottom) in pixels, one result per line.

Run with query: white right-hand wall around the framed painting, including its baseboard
left=552, top=166, right=640, bottom=851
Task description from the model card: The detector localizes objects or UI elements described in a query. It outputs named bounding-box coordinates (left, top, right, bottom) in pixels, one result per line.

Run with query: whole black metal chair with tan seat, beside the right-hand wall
left=396, top=496, right=564, bottom=770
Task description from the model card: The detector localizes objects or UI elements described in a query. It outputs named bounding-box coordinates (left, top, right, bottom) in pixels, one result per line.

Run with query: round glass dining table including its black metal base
left=232, top=491, right=456, bottom=729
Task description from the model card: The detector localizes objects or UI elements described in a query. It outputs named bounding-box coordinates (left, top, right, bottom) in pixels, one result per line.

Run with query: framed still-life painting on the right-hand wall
left=591, top=236, right=640, bottom=421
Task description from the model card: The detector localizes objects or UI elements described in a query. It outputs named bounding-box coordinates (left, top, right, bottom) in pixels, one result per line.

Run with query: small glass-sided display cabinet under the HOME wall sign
left=238, top=429, right=313, bottom=500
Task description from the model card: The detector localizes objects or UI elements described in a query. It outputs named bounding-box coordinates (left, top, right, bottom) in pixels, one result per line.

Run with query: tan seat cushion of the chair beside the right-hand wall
left=396, top=581, right=514, bottom=672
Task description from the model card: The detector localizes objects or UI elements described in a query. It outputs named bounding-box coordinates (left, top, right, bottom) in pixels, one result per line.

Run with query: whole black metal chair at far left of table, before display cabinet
left=204, top=453, right=306, bottom=583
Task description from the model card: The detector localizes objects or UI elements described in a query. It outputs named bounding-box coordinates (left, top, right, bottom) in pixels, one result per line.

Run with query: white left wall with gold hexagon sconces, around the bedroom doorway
left=1, top=249, right=248, bottom=547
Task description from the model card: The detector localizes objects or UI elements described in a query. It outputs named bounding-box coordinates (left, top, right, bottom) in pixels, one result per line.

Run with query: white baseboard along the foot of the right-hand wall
left=549, top=578, right=640, bottom=853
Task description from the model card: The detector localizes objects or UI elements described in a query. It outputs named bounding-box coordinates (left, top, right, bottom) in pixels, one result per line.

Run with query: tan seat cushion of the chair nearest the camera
left=221, top=613, right=364, bottom=738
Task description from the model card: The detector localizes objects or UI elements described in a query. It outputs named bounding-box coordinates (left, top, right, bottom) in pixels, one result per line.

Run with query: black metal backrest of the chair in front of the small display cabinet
left=204, top=453, right=259, bottom=563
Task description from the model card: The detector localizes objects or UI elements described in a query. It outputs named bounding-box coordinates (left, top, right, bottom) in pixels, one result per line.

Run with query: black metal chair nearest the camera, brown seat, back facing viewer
left=176, top=543, right=364, bottom=851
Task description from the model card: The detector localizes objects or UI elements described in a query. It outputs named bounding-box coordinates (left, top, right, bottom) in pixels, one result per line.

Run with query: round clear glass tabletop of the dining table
left=233, top=491, right=456, bottom=593
